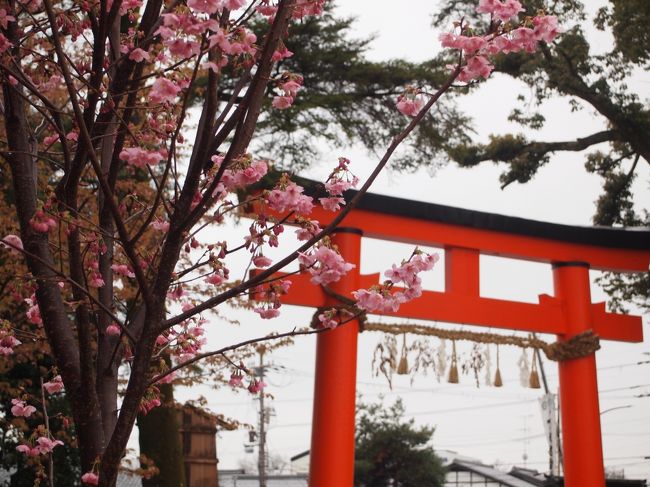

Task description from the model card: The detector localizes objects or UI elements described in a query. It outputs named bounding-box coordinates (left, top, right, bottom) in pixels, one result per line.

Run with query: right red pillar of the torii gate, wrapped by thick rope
left=553, top=262, right=605, bottom=487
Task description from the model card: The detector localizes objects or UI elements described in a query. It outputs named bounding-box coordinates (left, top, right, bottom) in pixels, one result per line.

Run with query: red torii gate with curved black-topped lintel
left=256, top=192, right=650, bottom=487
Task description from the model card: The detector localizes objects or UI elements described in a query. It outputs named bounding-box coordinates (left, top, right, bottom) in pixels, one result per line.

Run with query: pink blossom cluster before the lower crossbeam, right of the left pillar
left=352, top=249, right=439, bottom=313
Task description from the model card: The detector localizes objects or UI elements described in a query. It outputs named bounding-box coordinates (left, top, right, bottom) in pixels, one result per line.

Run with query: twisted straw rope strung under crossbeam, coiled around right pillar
left=364, top=323, right=600, bottom=361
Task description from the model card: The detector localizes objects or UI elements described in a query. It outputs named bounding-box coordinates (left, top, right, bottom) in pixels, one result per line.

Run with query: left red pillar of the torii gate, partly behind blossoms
left=309, top=228, right=363, bottom=487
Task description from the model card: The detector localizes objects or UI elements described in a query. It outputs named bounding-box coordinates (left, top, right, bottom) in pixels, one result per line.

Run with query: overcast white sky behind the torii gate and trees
left=158, top=0, right=650, bottom=479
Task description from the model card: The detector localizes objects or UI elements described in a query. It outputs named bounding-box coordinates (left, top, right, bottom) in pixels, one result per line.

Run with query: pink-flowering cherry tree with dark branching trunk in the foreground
left=0, top=0, right=558, bottom=485
